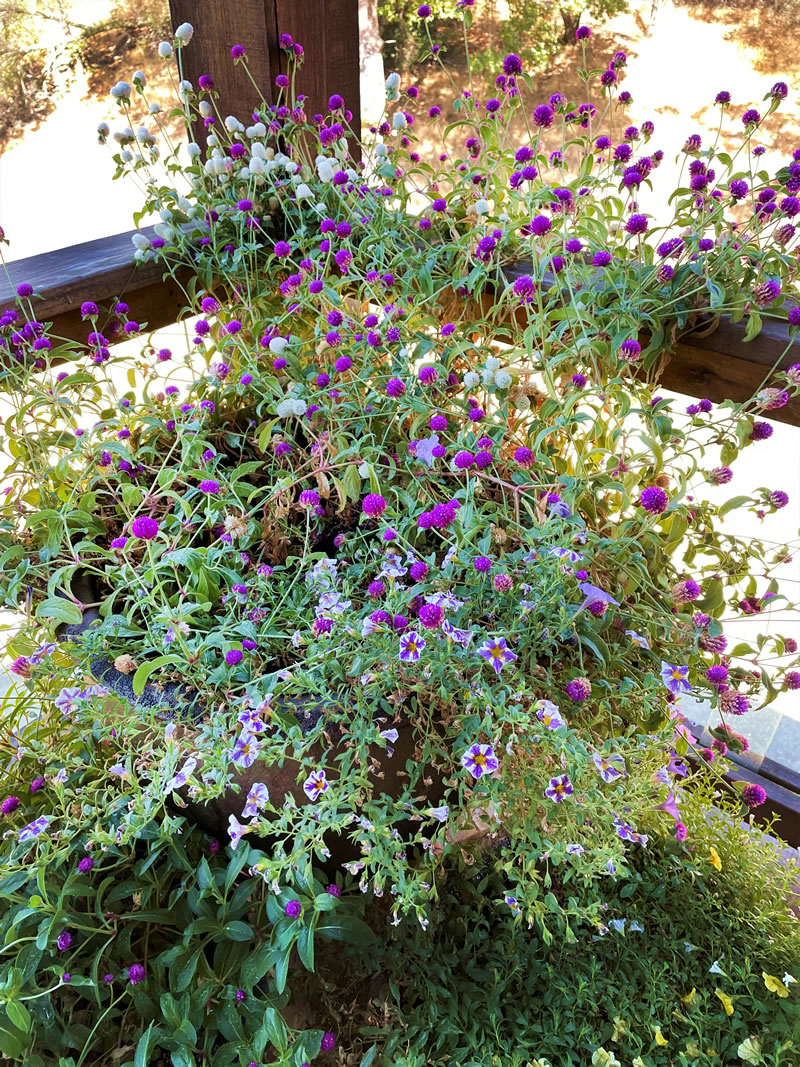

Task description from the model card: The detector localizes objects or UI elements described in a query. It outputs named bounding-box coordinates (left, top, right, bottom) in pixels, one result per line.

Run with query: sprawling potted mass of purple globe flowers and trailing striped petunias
left=0, top=5, right=800, bottom=1063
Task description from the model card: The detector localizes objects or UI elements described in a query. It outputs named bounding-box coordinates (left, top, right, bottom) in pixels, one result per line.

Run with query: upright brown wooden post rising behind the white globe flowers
left=170, top=0, right=361, bottom=130
